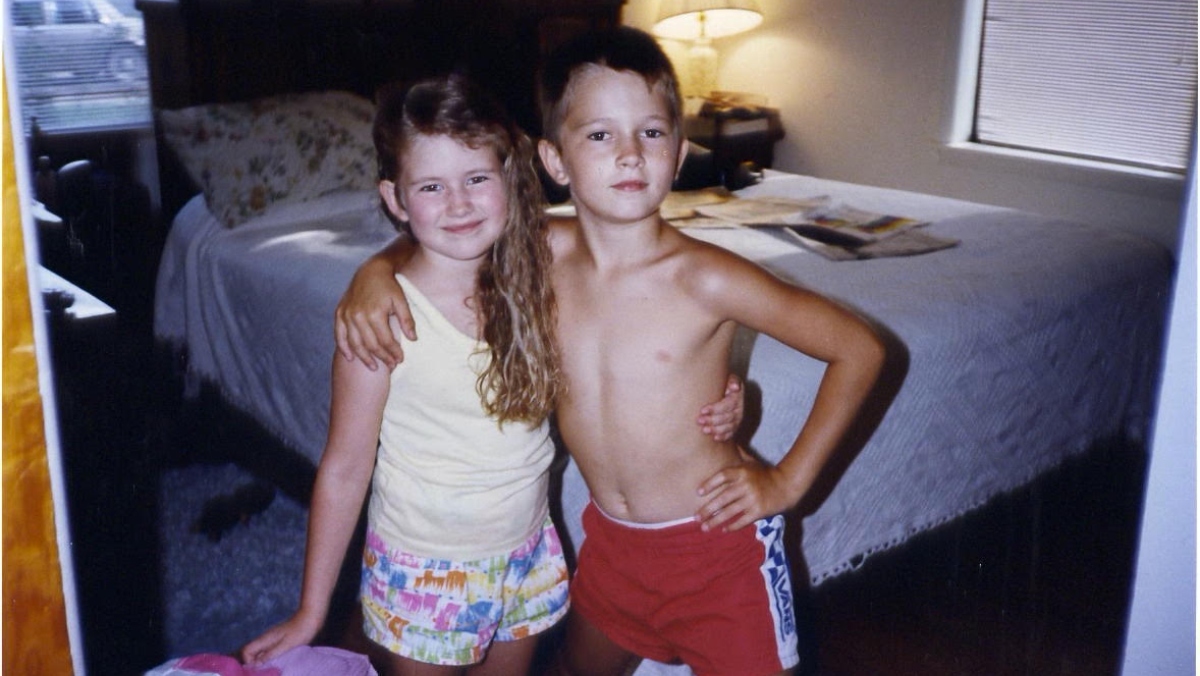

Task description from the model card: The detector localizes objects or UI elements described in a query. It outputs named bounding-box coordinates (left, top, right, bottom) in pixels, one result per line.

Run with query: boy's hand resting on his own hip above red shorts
left=696, top=449, right=798, bottom=531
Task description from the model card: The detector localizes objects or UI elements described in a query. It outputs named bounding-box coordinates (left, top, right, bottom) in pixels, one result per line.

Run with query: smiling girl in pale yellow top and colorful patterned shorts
left=242, top=77, right=568, bottom=675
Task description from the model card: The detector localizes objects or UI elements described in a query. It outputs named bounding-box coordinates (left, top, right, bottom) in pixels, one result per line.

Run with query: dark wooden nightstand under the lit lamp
left=684, top=106, right=784, bottom=186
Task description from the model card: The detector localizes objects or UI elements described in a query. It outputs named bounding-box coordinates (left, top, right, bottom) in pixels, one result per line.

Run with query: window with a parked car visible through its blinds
left=6, top=0, right=151, bottom=134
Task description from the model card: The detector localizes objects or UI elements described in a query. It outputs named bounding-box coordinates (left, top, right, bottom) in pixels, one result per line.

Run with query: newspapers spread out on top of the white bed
left=664, top=191, right=958, bottom=261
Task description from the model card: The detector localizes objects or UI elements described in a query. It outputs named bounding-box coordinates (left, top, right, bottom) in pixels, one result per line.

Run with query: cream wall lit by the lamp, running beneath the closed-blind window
left=624, top=0, right=1183, bottom=250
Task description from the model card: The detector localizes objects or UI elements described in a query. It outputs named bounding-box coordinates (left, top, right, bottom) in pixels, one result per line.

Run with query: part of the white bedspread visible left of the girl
left=155, top=191, right=396, bottom=463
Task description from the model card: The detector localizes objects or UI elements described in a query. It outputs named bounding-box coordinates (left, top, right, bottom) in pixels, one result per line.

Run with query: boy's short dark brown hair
left=538, top=26, right=683, bottom=145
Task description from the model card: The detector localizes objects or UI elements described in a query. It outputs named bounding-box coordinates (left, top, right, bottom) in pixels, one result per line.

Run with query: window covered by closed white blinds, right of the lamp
left=973, top=0, right=1196, bottom=173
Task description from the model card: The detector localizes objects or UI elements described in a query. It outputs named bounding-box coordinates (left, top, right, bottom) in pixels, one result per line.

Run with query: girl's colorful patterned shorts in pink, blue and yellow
left=361, top=519, right=569, bottom=665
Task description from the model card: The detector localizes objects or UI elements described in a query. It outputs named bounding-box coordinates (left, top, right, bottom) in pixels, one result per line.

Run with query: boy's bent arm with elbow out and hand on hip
left=697, top=261, right=886, bottom=530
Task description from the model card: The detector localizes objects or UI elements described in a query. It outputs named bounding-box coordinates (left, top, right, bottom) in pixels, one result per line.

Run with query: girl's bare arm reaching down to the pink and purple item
left=241, top=358, right=389, bottom=664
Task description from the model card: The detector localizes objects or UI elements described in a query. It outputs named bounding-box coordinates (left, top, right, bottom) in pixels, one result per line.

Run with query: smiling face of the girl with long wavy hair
left=379, top=134, right=509, bottom=261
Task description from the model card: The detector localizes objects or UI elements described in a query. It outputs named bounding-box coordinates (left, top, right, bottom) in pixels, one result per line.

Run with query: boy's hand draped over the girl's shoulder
left=334, top=237, right=416, bottom=370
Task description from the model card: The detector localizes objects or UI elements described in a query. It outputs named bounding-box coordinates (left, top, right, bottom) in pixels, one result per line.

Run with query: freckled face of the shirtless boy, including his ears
left=539, top=66, right=686, bottom=229
